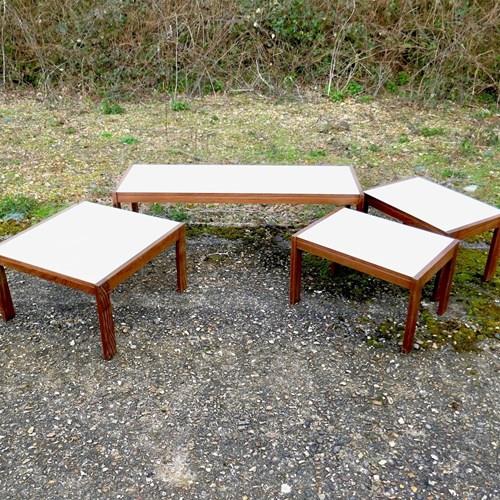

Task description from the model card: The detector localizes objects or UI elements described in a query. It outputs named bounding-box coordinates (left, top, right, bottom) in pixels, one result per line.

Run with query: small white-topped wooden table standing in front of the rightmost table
left=290, top=208, right=459, bottom=352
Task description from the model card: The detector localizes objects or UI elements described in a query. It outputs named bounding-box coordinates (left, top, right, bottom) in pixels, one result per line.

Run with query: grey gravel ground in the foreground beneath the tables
left=0, top=234, right=500, bottom=500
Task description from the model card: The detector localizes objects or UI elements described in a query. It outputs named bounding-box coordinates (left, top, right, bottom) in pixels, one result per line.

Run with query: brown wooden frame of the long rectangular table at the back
left=112, top=165, right=364, bottom=212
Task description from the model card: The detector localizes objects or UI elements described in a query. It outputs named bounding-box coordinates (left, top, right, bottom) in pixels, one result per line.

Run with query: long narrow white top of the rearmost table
left=116, top=165, right=361, bottom=195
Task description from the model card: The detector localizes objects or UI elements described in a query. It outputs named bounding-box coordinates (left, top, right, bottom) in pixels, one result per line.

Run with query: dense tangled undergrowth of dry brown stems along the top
left=0, top=0, right=500, bottom=102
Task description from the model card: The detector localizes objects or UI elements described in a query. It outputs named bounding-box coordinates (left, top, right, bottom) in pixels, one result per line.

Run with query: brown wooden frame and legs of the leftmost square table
left=0, top=208, right=187, bottom=360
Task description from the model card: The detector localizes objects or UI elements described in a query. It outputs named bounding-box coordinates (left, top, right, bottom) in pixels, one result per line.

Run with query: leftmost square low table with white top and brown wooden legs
left=0, top=202, right=186, bottom=359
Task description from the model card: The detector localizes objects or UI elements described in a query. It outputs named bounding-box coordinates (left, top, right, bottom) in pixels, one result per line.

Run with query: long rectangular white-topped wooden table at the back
left=113, top=165, right=363, bottom=211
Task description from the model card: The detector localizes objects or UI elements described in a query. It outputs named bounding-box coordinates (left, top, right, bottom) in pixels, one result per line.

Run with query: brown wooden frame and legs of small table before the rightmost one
left=290, top=212, right=459, bottom=353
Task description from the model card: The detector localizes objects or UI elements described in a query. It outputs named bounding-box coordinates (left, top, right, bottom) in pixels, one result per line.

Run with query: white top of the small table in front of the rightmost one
left=298, top=208, right=454, bottom=278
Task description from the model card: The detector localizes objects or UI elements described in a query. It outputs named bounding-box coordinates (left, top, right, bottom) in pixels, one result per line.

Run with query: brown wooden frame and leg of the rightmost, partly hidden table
left=363, top=181, right=500, bottom=281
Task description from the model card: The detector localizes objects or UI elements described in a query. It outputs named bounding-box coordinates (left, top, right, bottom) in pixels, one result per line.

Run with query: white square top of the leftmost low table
left=0, top=202, right=181, bottom=285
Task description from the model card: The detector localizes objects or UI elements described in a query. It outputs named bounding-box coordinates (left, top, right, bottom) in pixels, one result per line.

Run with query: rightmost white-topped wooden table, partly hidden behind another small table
left=365, top=177, right=500, bottom=281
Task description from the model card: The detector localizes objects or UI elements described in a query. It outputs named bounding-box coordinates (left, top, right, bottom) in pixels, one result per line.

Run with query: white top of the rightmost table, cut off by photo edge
left=366, top=177, right=500, bottom=233
